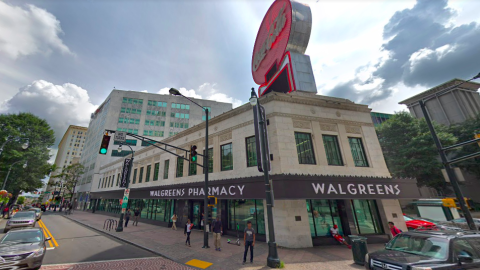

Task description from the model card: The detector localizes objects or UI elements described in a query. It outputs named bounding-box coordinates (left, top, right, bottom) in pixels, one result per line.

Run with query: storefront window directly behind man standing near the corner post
left=228, top=200, right=265, bottom=234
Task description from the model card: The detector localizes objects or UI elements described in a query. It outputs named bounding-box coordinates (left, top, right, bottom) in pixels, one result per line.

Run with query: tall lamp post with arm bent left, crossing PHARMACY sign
left=168, top=88, right=210, bottom=248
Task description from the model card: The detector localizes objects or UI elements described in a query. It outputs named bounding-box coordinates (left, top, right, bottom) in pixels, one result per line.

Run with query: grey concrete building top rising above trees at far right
left=399, top=79, right=480, bottom=126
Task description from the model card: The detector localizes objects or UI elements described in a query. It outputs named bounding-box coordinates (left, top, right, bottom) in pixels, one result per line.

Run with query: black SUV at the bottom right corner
left=365, top=231, right=480, bottom=270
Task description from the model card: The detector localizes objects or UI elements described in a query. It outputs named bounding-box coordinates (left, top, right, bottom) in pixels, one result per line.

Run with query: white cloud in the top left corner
left=0, top=1, right=71, bottom=59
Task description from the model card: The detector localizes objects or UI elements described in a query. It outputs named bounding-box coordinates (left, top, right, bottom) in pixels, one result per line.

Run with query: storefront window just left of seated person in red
left=307, top=200, right=343, bottom=237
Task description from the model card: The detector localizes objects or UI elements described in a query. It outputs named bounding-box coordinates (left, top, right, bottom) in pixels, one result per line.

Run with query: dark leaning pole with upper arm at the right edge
left=418, top=73, right=480, bottom=231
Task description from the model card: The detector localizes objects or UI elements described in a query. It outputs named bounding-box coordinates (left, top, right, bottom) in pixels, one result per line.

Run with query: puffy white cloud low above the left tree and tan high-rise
left=0, top=80, right=97, bottom=146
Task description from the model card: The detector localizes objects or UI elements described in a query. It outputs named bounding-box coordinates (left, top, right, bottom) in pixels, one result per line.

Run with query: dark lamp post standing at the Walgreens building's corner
left=249, top=88, right=280, bottom=268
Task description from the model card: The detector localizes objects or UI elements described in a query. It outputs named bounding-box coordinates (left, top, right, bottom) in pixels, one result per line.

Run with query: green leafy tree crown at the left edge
left=0, top=113, right=55, bottom=196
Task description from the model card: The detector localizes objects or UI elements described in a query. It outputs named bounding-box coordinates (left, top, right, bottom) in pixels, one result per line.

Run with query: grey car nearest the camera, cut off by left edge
left=0, top=228, right=51, bottom=269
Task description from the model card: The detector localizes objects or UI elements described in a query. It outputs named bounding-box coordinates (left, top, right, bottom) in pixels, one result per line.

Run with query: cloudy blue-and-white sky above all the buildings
left=0, top=0, right=480, bottom=165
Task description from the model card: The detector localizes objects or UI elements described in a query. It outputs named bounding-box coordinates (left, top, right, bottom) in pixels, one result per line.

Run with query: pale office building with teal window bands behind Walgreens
left=76, top=89, right=232, bottom=207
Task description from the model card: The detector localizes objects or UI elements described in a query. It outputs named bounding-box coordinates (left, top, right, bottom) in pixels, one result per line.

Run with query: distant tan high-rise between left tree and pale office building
left=43, top=125, right=88, bottom=202
